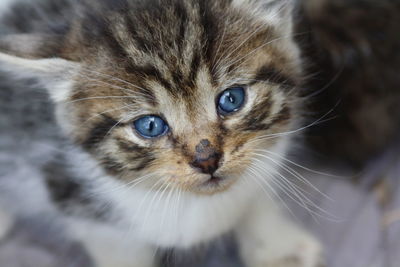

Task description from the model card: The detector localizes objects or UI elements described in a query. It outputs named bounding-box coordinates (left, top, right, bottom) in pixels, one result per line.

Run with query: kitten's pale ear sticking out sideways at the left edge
left=0, top=34, right=80, bottom=102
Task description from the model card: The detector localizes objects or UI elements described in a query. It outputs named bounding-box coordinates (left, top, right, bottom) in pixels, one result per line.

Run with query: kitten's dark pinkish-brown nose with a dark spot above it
left=191, top=139, right=221, bottom=174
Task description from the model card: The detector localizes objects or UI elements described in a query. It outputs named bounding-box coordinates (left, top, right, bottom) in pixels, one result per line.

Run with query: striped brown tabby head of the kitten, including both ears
left=0, top=0, right=300, bottom=197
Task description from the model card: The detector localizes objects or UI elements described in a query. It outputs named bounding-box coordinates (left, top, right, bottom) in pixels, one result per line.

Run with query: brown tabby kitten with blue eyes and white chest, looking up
left=0, top=0, right=321, bottom=267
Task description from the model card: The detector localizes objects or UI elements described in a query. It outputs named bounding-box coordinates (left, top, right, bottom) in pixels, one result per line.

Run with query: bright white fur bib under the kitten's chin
left=65, top=137, right=286, bottom=248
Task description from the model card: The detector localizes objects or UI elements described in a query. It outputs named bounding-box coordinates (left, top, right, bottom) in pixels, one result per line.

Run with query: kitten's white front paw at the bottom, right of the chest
left=249, top=236, right=326, bottom=267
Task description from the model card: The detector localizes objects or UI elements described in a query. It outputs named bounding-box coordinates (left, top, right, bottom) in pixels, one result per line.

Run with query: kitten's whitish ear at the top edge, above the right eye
left=232, top=0, right=296, bottom=36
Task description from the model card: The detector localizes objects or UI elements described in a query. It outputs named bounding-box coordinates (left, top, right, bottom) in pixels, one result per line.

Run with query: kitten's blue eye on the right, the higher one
left=218, top=87, right=246, bottom=114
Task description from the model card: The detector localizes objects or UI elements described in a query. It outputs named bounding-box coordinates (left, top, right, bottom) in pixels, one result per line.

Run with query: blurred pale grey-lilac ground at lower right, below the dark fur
left=299, top=146, right=400, bottom=267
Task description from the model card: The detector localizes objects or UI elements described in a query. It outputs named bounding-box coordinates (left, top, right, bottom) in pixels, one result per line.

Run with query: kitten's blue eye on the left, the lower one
left=133, top=115, right=169, bottom=138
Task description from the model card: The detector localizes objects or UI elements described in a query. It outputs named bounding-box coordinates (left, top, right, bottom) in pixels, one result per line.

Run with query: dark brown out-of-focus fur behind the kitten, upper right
left=297, top=0, right=400, bottom=167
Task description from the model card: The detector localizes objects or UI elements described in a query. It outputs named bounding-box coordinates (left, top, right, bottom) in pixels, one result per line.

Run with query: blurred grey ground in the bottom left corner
left=0, top=216, right=93, bottom=267
